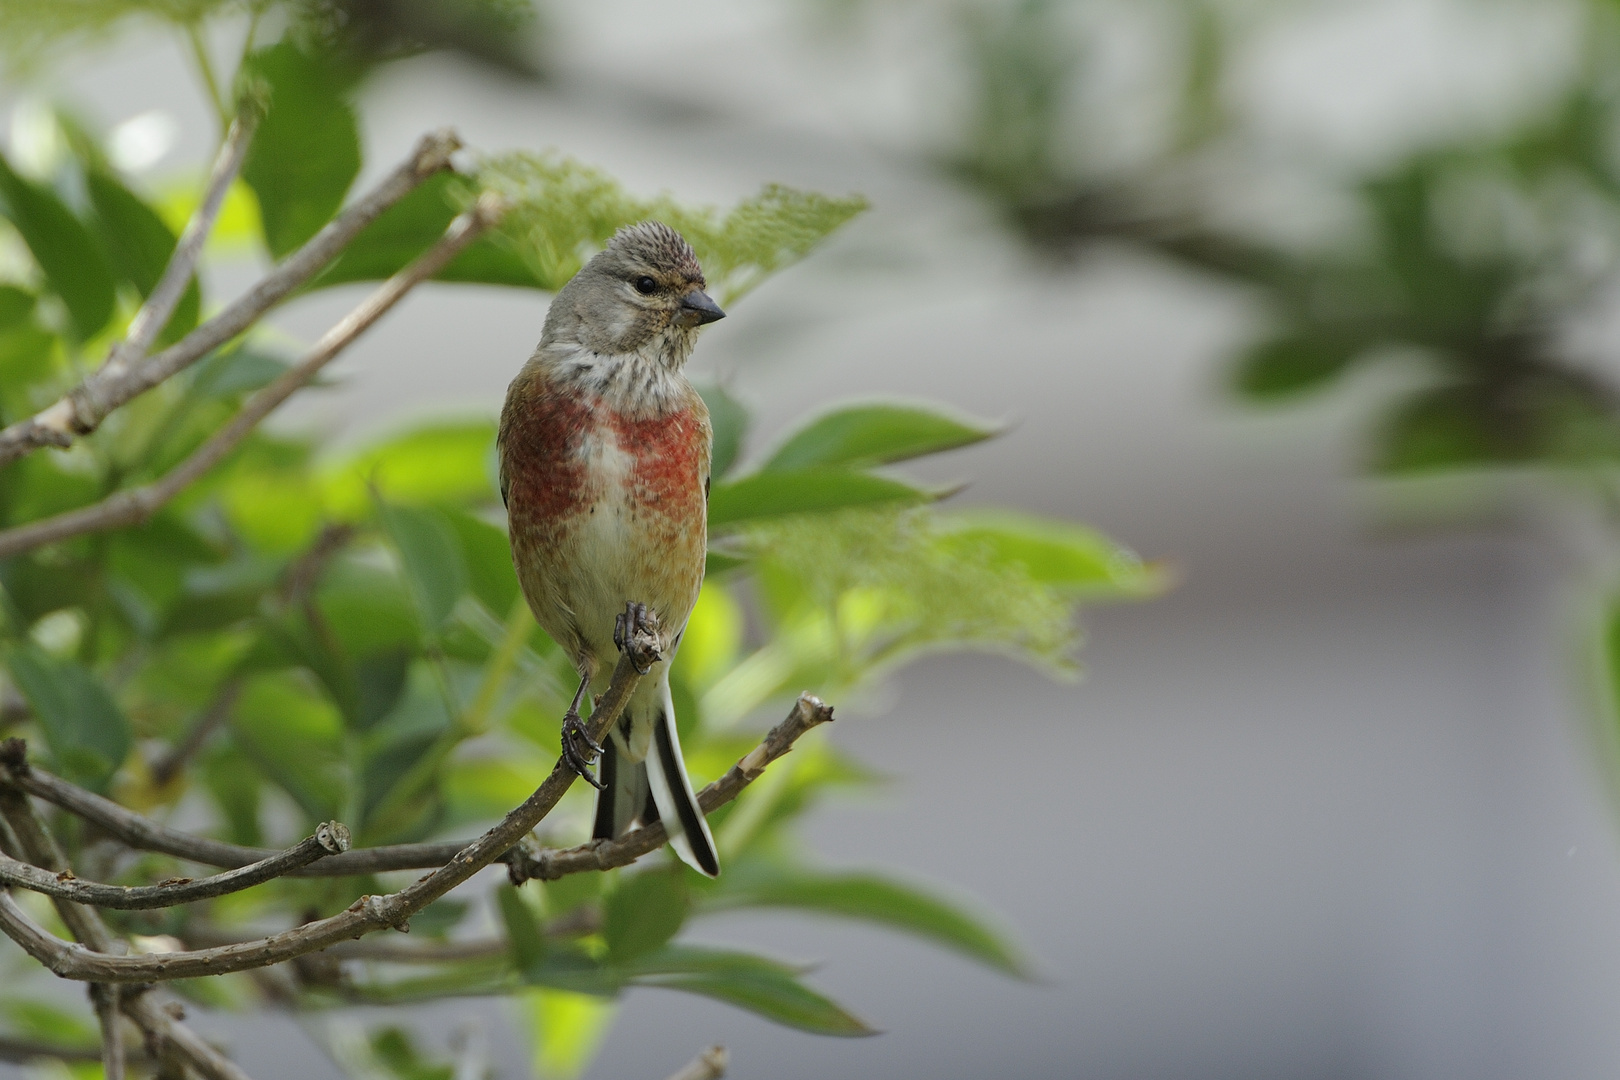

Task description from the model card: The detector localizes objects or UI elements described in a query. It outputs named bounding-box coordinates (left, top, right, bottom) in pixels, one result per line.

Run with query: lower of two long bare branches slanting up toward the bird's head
left=0, top=194, right=505, bottom=559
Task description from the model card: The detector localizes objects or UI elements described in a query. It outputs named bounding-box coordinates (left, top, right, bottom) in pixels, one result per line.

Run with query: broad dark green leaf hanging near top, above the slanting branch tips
left=241, top=42, right=360, bottom=259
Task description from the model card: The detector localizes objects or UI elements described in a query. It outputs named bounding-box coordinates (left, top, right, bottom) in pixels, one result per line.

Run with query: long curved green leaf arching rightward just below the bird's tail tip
left=705, top=868, right=1030, bottom=978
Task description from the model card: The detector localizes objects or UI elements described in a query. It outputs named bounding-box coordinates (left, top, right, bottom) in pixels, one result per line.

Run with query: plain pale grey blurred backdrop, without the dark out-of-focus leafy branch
left=9, top=0, right=1620, bottom=1080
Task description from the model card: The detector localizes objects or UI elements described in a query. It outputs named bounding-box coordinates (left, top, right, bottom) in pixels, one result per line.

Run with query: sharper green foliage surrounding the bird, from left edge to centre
left=0, top=2, right=1158, bottom=1080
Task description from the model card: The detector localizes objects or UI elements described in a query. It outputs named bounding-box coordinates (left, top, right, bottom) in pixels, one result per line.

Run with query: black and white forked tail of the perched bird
left=591, top=682, right=719, bottom=878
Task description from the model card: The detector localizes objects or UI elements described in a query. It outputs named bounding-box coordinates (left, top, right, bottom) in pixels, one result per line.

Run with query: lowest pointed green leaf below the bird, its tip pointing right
left=630, top=947, right=876, bottom=1036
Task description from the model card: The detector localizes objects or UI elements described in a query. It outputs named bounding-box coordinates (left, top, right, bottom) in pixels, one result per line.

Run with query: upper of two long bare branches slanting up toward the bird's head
left=0, top=131, right=462, bottom=468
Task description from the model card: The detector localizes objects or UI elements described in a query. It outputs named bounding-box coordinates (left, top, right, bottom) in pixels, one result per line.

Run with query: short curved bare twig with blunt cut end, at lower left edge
left=0, top=821, right=348, bottom=912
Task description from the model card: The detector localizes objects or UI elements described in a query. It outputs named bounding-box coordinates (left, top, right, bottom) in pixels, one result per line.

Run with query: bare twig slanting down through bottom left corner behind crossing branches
left=0, top=787, right=251, bottom=1080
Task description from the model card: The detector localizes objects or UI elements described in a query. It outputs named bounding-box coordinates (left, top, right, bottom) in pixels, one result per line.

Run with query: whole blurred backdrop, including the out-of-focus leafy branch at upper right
left=15, top=0, right=1620, bottom=1080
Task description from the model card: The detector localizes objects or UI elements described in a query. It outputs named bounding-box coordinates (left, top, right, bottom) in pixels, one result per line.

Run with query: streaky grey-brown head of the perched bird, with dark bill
left=541, top=222, right=726, bottom=366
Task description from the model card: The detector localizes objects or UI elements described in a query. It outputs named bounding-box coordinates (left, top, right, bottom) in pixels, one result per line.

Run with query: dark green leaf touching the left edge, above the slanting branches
left=0, top=145, right=117, bottom=340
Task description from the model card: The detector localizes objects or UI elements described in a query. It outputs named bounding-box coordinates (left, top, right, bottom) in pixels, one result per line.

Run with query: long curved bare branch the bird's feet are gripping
left=0, top=633, right=657, bottom=983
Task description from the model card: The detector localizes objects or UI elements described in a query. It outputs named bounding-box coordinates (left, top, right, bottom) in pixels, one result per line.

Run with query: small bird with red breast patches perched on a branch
left=496, top=220, right=726, bottom=878
